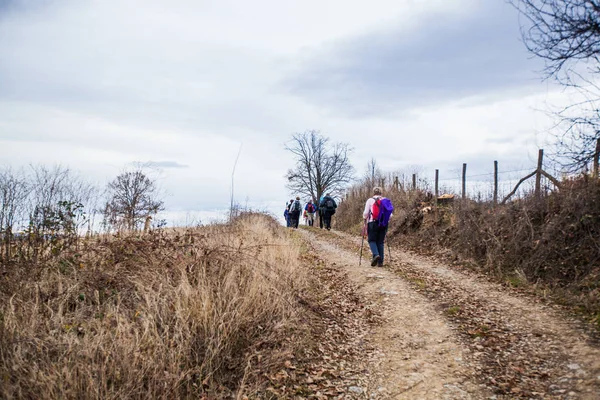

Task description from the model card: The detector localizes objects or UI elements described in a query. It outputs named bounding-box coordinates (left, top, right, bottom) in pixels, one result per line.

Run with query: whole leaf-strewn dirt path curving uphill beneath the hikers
left=302, top=230, right=600, bottom=399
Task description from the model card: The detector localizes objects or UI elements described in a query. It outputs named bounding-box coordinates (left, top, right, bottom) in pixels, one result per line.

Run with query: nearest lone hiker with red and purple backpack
left=363, top=187, right=394, bottom=267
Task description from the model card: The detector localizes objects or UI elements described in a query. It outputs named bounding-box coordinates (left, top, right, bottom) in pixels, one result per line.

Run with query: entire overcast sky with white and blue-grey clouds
left=0, top=0, right=564, bottom=225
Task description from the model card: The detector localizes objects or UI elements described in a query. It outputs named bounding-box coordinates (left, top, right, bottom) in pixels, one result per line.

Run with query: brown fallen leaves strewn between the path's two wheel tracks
left=316, top=230, right=595, bottom=399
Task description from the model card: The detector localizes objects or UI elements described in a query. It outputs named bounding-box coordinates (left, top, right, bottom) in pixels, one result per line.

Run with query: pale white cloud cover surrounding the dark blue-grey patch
left=0, top=0, right=576, bottom=225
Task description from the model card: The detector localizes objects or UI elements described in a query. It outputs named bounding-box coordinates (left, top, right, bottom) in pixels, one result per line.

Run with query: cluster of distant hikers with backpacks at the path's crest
left=283, top=193, right=337, bottom=230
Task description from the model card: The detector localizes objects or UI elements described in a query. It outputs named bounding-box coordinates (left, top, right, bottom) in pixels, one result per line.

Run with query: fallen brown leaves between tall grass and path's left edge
left=258, top=247, right=379, bottom=400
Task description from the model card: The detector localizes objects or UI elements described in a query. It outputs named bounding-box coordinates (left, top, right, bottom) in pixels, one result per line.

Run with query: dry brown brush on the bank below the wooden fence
left=336, top=176, right=600, bottom=326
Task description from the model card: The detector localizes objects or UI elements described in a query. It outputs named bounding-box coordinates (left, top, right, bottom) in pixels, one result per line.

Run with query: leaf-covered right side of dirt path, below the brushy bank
left=319, top=227, right=600, bottom=399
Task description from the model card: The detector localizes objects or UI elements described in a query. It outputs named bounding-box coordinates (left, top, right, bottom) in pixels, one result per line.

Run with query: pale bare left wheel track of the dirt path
left=300, top=229, right=492, bottom=399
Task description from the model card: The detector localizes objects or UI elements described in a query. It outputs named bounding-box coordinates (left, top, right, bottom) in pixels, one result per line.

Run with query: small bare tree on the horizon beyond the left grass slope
left=104, top=168, right=164, bottom=230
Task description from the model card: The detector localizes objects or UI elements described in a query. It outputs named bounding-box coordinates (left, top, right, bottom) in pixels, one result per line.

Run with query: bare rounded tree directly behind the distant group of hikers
left=286, top=130, right=354, bottom=201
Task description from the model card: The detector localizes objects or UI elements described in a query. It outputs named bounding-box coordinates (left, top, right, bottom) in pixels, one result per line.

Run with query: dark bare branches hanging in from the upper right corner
left=510, top=0, right=600, bottom=170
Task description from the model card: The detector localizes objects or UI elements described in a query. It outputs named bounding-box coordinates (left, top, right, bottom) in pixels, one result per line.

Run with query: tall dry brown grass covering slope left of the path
left=0, top=214, right=308, bottom=399
